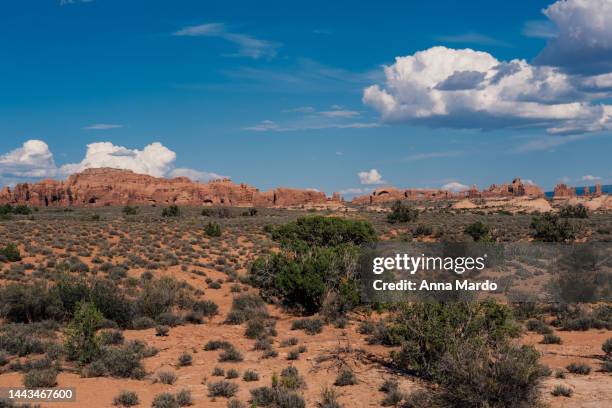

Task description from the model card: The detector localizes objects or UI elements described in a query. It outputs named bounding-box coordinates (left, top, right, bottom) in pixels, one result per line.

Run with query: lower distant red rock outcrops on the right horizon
left=353, top=178, right=544, bottom=204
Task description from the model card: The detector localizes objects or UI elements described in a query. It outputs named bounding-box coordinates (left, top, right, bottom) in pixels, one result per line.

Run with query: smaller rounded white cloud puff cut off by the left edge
left=0, top=140, right=56, bottom=177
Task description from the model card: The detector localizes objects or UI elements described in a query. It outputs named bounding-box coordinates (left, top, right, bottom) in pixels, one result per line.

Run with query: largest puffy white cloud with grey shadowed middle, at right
left=363, top=47, right=612, bottom=134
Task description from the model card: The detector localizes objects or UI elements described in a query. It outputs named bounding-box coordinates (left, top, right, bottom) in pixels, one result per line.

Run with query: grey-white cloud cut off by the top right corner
left=536, top=0, right=612, bottom=73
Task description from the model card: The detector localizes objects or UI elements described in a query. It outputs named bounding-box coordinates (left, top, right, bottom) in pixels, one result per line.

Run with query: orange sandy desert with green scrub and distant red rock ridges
left=0, top=169, right=612, bottom=408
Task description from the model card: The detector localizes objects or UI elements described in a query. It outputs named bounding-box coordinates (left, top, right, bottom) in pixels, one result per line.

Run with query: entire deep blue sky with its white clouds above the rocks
left=0, top=0, right=612, bottom=195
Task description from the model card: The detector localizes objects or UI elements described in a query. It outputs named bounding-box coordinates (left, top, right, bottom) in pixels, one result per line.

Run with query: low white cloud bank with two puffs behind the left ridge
left=0, top=140, right=224, bottom=183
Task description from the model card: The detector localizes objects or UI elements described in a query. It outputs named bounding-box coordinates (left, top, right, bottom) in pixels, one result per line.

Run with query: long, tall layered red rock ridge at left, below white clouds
left=0, top=168, right=328, bottom=207
